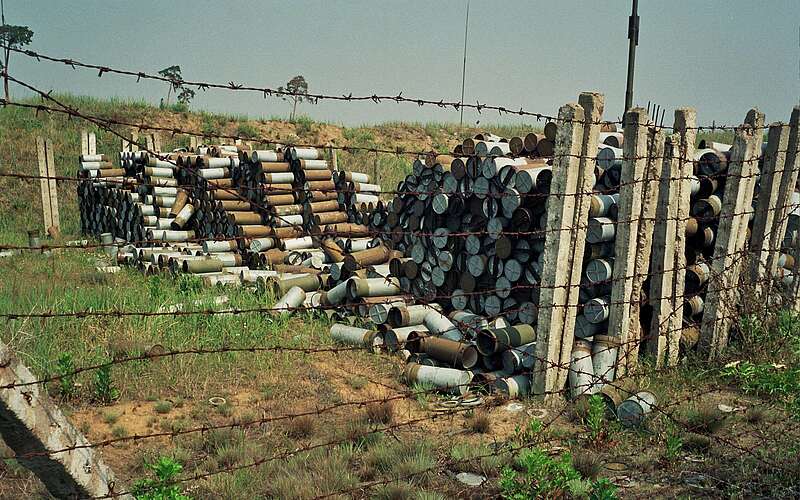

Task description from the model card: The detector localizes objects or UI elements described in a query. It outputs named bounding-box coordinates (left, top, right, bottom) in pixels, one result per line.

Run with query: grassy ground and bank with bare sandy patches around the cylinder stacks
left=0, top=95, right=800, bottom=498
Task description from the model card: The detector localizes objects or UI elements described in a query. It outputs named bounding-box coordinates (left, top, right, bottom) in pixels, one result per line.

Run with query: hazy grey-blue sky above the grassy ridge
left=5, top=0, right=800, bottom=124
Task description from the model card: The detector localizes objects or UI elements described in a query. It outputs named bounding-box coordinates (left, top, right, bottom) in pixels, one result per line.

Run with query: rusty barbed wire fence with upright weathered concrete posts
left=0, top=49, right=800, bottom=498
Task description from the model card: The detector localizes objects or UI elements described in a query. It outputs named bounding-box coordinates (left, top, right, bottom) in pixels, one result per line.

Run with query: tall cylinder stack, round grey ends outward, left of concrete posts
left=382, top=150, right=552, bottom=323
